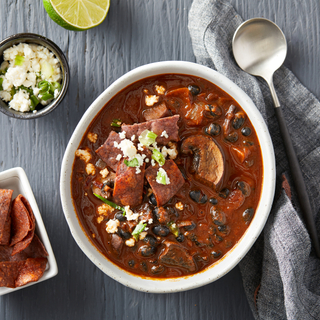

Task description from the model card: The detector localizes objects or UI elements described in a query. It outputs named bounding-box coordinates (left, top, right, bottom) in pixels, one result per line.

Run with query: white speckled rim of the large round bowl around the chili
left=60, top=61, right=275, bottom=293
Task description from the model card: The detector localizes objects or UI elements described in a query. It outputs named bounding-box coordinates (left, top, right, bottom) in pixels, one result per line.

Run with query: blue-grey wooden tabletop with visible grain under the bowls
left=0, top=0, right=320, bottom=320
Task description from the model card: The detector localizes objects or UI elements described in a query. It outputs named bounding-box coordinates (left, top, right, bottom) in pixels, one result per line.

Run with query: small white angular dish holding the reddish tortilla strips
left=0, top=167, right=58, bottom=296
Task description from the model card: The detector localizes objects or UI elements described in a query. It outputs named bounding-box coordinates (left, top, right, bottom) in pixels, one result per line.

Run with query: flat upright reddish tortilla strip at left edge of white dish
left=0, top=189, right=13, bottom=245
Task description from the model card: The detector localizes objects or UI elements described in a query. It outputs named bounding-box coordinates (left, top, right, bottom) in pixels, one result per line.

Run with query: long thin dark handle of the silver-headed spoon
left=275, top=105, right=320, bottom=258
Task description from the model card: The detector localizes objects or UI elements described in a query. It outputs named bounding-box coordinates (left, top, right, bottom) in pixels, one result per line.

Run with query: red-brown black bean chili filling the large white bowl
left=72, top=74, right=263, bottom=278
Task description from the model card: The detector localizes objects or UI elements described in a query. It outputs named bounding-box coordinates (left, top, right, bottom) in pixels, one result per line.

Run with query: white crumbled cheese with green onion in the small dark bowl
left=0, top=43, right=62, bottom=112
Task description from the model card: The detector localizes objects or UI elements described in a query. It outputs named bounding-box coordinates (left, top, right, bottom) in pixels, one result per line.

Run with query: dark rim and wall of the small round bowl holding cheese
left=0, top=33, right=70, bottom=120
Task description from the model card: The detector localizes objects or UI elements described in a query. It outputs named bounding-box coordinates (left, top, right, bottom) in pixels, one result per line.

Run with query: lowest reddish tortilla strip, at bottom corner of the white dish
left=15, top=258, right=47, bottom=287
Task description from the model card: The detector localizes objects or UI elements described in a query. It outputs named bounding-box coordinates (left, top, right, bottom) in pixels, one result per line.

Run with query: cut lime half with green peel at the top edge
left=43, top=0, right=110, bottom=31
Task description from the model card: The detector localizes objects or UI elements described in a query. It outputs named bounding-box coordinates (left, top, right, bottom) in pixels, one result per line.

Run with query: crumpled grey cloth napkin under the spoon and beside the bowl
left=189, top=0, right=320, bottom=320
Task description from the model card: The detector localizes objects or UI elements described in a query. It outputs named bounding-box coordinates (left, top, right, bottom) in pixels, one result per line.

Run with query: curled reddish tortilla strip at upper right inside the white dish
left=10, top=195, right=32, bottom=246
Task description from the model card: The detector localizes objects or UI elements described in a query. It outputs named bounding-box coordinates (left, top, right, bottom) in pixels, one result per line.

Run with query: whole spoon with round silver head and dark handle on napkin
left=232, top=18, right=320, bottom=258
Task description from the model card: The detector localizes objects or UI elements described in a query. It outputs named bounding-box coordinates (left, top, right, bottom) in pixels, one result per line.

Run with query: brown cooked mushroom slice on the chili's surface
left=181, top=134, right=225, bottom=187
